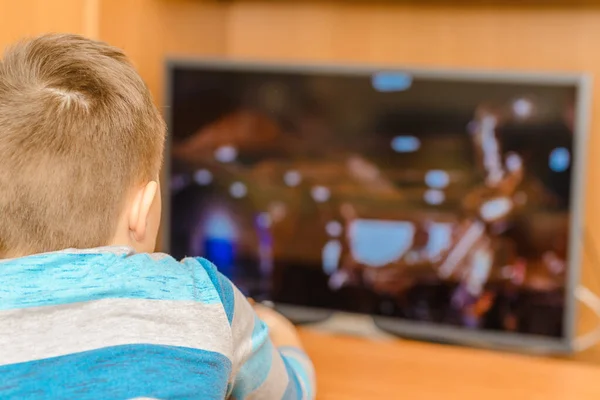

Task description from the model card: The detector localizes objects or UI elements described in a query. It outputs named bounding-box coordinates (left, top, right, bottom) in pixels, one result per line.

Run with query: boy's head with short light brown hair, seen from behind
left=0, top=35, right=165, bottom=258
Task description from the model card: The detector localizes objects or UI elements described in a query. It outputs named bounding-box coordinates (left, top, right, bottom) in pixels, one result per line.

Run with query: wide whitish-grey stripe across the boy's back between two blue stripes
left=0, top=299, right=232, bottom=365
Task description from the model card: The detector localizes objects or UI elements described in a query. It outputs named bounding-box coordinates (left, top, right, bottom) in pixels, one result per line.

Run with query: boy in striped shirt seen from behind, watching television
left=0, top=35, right=314, bottom=399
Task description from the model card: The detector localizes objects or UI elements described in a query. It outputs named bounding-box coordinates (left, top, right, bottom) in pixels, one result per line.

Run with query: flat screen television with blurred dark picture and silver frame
left=164, top=60, right=589, bottom=351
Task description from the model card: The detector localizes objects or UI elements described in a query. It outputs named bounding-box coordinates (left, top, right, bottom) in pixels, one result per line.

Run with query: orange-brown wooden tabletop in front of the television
left=300, top=328, right=600, bottom=400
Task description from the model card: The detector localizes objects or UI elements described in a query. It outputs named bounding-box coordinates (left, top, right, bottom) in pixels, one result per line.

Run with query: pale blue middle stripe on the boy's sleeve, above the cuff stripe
left=232, top=316, right=275, bottom=399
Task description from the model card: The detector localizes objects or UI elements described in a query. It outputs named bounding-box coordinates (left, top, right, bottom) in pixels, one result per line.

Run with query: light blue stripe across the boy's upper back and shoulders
left=0, top=253, right=221, bottom=310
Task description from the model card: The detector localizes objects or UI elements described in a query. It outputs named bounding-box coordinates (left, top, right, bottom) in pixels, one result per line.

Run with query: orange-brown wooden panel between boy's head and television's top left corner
left=99, top=0, right=228, bottom=105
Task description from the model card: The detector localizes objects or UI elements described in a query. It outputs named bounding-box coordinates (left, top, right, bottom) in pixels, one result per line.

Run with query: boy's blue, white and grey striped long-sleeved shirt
left=0, top=248, right=315, bottom=400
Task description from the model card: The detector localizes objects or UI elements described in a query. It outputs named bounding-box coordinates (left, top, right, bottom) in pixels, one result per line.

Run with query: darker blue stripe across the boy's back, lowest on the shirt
left=0, top=345, right=231, bottom=400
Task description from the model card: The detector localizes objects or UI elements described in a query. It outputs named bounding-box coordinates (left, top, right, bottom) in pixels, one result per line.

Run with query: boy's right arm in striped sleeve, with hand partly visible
left=199, top=260, right=315, bottom=400
